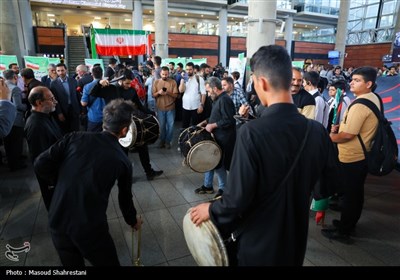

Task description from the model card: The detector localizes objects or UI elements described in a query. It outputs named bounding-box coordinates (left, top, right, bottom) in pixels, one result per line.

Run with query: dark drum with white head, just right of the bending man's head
left=119, top=115, right=160, bottom=148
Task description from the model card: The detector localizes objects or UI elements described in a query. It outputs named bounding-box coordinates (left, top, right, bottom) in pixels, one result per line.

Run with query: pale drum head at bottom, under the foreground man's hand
left=183, top=209, right=229, bottom=266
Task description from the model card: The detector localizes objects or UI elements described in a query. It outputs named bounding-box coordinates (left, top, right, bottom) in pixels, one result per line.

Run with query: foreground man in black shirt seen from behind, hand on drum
left=191, top=45, right=338, bottom=266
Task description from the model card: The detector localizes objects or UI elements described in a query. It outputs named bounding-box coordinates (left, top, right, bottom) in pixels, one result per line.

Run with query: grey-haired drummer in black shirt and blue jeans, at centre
left=195, top=77, right=236, bottom=197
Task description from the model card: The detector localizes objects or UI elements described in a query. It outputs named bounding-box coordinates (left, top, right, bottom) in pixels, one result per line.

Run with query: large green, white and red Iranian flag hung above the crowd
left=91, top=28, right=150, bottom=58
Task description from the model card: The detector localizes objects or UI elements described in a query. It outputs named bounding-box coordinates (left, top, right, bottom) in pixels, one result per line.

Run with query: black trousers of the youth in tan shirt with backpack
left=339, top=160, right=367, bottom=234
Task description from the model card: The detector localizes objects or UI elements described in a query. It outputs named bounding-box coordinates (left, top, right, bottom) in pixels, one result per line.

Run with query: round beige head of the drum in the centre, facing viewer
left=187, top=140, right=222, bottom=173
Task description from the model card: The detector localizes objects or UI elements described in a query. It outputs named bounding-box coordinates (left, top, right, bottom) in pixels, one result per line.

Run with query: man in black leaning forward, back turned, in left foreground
left=35, top=100, right=142, bottom=267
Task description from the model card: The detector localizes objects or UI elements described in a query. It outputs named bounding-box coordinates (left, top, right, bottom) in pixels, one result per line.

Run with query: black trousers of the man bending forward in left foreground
left=51, top=231, right=120, bottom=267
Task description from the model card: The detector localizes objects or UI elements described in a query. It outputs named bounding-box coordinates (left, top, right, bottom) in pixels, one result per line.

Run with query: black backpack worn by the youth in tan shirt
left=348, top=94, right=399, bottom=176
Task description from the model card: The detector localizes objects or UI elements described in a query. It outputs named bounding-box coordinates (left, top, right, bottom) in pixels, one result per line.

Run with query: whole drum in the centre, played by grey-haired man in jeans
left=178, top=126, right=222, bottom=173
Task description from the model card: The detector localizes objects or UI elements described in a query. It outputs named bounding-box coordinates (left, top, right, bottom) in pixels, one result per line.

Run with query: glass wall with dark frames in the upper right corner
left=347, top=0, right=400, bottom=45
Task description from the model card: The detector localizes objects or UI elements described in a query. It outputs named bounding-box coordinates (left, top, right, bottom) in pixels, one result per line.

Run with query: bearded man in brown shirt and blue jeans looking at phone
left=152, top=66, right=178, bottom=149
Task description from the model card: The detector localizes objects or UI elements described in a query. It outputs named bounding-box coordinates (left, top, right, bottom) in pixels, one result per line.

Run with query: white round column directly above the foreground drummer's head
left=247, top=0, right=277, bottom=58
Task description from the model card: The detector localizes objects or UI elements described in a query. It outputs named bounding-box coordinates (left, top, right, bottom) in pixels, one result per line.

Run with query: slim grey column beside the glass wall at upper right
left=335, top=1, right=350, bottom=67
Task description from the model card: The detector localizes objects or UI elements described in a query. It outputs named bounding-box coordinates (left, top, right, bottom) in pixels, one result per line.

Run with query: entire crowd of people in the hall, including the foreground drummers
left=0, top=45, right=395, bottom=266
